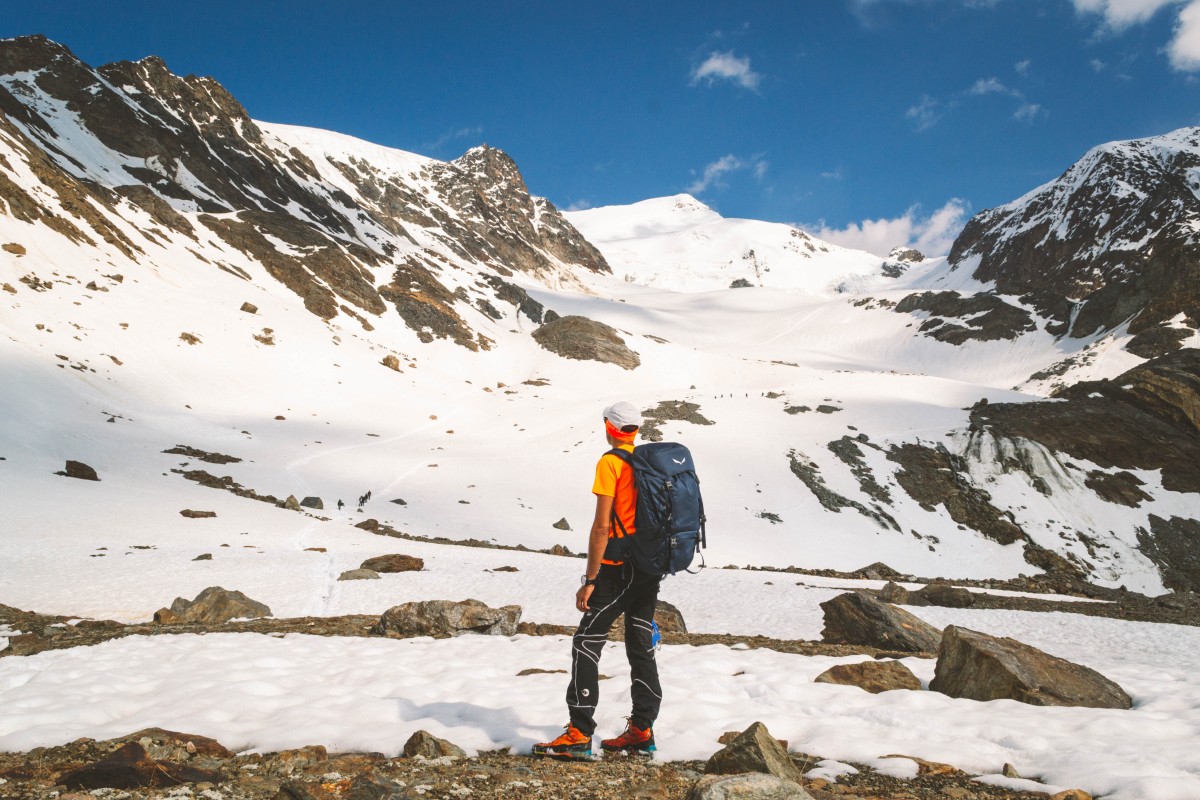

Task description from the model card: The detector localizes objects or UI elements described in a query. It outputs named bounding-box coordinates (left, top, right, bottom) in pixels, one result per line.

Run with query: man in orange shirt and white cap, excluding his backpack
left=533, top=402, right=662, bottom=758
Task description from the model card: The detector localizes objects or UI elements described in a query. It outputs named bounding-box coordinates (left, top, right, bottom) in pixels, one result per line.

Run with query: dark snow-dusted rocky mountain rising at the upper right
left=949, top=128, right=1200, bottom=336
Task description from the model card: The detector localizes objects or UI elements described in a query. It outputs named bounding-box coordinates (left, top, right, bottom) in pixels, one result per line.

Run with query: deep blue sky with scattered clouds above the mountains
left=0, top=0, right=1200, bottom=252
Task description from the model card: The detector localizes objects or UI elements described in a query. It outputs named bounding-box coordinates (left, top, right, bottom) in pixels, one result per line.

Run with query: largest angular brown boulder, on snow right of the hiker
left=929, top=625, right=1133, bottom=709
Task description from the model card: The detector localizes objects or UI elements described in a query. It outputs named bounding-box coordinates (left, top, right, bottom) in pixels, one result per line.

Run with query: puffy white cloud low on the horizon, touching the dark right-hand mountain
left=805, top=198, right=970, bottom=258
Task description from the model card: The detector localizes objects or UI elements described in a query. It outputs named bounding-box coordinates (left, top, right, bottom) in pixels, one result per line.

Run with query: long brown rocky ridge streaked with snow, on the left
left=0, top=36, right=608, bottom=348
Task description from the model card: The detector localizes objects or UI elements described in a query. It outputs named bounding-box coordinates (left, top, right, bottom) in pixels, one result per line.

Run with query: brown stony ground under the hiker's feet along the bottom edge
left=0, top=724, right=1088, bottom=800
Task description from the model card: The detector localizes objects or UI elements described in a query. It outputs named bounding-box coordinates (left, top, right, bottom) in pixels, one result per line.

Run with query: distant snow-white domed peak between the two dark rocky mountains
left=565, top=194, right=883, bottom=294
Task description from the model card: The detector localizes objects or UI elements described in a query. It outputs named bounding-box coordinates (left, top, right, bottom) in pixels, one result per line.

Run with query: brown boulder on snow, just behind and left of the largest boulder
left=821, top=591, right=942, bottom=652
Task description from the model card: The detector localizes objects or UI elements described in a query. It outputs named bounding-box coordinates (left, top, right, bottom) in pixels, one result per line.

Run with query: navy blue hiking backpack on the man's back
left=605, top=441, right=708, bottom=575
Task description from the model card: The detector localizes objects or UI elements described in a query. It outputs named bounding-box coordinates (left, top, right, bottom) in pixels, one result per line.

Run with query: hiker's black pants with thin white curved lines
left=566, top=564, right=662, bottom=736
